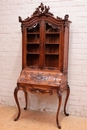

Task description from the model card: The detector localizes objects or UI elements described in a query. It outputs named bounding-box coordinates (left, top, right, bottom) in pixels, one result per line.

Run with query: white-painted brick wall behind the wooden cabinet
left=0, top=0, right=87, bottom=117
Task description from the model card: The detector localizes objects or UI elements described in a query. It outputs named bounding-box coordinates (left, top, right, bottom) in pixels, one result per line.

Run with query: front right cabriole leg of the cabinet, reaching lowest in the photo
left=56, top=91, right=62, bottom=129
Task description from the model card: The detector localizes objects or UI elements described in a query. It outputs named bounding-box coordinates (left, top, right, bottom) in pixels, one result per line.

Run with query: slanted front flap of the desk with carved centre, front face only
left=18, top=72, right=62, bottom=87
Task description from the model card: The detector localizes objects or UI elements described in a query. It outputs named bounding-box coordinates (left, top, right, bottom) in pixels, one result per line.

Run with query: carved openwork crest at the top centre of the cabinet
left=33, top=3, right=53, bottom=16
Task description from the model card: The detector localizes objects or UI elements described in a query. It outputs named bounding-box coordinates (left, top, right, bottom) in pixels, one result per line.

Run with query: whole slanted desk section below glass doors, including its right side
left=17, top=67, right=66, bottom=87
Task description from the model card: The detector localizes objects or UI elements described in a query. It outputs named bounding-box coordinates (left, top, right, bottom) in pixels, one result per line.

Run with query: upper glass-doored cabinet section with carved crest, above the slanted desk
left=19, top=3, right=70, bottom=71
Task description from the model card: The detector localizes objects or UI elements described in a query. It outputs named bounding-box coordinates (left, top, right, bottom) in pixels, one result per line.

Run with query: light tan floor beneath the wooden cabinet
left=0, top=105, right=87, bottom=130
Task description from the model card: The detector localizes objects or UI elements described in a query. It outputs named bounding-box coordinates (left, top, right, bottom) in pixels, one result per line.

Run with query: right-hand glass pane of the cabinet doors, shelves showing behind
left=45, top=23, right=60, bottom=69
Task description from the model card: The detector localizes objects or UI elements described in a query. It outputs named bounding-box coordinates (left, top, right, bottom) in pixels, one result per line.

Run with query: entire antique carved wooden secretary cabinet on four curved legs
left=14, top=3, right=70, bottom=128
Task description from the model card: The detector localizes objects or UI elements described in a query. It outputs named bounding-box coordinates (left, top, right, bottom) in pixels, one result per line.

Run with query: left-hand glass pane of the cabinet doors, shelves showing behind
left=26, top=23, right=40, bottom=67
